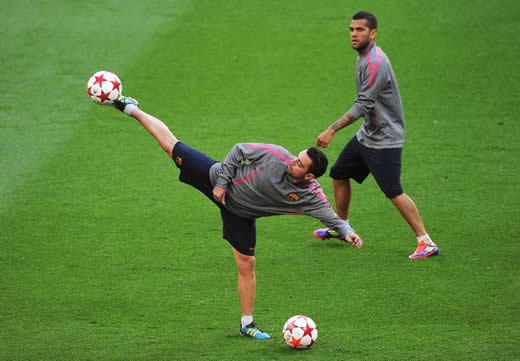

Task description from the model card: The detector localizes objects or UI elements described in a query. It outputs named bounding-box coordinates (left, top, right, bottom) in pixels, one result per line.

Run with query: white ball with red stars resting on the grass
left=282, top=315, right=318, bottom=349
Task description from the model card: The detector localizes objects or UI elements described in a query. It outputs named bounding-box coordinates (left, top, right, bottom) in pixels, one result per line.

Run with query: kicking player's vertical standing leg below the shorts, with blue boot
left=233, top=248, right=271, bottom=339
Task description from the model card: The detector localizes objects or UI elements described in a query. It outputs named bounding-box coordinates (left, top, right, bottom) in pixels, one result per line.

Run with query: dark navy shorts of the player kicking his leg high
left=172, top=142, right=256, bottom=256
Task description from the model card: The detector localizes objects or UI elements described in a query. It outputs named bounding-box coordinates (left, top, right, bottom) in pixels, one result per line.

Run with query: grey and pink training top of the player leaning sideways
left=209, top=143, right=355, bottom=236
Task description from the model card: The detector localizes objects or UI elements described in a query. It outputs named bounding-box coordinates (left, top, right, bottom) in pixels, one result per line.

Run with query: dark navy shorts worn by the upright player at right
left=330, top=136, right=403, bottom=198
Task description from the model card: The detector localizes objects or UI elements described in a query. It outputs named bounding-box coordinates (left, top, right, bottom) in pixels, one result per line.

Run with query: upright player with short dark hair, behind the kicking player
left=314, top=11, right=439, bottom=259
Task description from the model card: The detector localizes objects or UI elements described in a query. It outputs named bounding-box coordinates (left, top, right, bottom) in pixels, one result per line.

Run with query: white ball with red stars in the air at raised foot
left=87, top=70, right=123, bottom=105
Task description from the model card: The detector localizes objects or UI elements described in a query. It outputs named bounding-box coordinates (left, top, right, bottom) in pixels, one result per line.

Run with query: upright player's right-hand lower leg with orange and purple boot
left=392, top=193, right=439, bottom=259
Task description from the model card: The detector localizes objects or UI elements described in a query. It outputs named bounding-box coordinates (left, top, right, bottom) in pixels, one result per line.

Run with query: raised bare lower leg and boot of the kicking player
left=114, top=96, right=178, bottom=158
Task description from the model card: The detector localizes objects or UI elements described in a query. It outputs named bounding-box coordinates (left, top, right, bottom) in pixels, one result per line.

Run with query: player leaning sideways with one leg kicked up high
left=109, top=96, right=363, bottom=339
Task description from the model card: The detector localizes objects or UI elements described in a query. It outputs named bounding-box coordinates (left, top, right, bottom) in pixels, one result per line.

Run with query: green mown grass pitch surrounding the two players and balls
left=0, top=0, right=520, bottom=360
